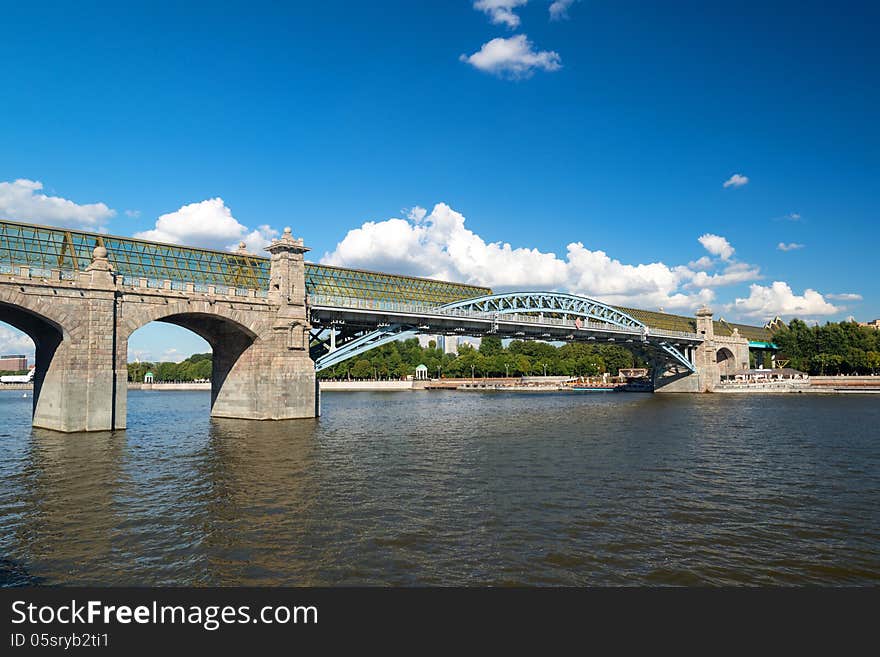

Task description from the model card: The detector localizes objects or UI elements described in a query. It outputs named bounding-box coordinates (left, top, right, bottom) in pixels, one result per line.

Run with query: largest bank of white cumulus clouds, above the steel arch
left=321, top=203, right=740, bottom=309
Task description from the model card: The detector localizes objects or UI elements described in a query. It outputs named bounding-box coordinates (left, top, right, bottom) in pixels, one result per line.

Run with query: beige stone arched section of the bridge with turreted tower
left=0, top=229, right=320, bottom=432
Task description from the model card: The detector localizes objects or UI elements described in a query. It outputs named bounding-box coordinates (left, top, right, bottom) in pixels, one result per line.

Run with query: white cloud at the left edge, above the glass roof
left=0, top=178, right=116, bottom=228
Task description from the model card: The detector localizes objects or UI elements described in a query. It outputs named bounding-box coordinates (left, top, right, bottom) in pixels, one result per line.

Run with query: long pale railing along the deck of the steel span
left=308, top=294, right=699, bottom=340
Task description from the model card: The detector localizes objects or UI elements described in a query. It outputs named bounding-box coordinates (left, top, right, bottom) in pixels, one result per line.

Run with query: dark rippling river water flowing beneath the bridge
left=0, top=391, right=880, bottom=586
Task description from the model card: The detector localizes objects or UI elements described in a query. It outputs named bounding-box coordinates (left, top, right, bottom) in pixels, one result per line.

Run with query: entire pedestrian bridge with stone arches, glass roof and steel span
left=0, top=221, right=770, bottom=431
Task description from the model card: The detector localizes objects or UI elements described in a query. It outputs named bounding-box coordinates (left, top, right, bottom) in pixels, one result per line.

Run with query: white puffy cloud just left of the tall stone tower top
left=135, top=197, right=278, bottom=253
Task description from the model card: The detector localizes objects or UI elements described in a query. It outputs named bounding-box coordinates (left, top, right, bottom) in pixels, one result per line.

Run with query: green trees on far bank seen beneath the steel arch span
left=318, top=335, right=642, bottom=379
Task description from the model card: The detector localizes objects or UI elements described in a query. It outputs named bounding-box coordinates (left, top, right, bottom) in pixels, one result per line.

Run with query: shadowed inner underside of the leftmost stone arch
left=0, top=301, right=64, bottom=416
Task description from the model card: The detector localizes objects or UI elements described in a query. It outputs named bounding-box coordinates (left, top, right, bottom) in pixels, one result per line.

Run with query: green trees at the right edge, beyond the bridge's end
left=773, top=319, right=880, bottom=376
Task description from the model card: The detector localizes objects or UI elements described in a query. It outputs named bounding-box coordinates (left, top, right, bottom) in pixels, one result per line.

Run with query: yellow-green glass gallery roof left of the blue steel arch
left=0, top=221, right=491, bottom=305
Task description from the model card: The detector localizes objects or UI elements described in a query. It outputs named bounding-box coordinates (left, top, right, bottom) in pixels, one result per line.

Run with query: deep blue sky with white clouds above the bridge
left=0, top=0, right=880, bottom=358
